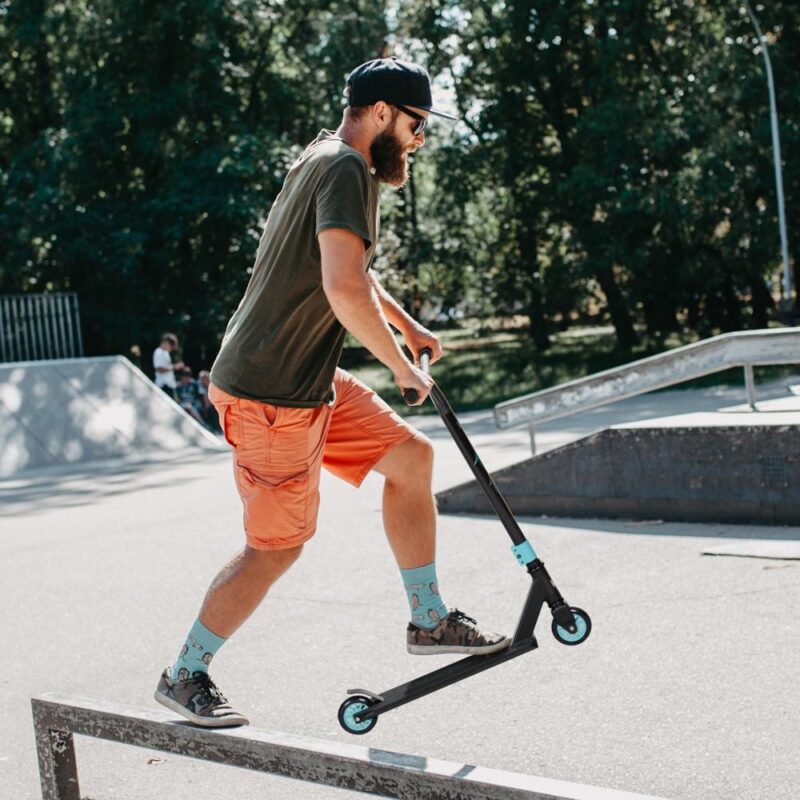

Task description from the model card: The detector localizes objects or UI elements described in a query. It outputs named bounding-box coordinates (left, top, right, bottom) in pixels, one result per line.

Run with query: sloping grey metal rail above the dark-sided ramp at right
left=494, top=327, right=800, bottom=453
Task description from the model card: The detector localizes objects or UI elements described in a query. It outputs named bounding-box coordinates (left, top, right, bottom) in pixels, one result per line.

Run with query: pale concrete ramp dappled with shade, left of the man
left=0, top=356, right=226, bottom=477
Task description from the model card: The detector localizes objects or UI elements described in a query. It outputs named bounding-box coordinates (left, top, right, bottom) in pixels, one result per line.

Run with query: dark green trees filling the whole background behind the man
left=0, top=0, right=800, bottom=370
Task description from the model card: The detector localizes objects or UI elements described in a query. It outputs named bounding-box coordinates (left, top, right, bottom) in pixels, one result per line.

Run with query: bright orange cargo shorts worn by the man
left=208, top=369, right=415, bottom=550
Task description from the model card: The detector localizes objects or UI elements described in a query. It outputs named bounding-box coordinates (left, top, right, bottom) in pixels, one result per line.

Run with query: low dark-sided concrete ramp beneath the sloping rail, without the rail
left=437, top=422, right=800, bottom=525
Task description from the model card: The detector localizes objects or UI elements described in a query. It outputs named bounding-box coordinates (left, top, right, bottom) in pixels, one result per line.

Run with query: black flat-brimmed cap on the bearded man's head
left=345, top=57, right=458, bottom=119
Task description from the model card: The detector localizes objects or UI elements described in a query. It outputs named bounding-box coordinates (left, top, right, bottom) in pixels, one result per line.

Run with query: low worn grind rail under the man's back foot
left=31, top=694, right=658, bottom=800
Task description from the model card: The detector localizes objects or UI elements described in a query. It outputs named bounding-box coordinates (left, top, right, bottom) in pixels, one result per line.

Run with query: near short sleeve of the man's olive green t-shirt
left=316, top=156, right=372, bottom=249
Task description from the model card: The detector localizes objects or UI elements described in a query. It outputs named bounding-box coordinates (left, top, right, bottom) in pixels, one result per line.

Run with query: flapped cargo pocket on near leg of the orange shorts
left=236, top=463, right=309, bottom=542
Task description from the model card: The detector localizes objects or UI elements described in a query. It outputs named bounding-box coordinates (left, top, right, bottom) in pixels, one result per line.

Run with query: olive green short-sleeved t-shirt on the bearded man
left=211, top=130, right=379, bottom=407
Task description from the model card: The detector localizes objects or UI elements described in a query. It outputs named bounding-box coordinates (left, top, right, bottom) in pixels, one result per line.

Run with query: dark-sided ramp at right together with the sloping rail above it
left=437, top=328, right=800, bottom=525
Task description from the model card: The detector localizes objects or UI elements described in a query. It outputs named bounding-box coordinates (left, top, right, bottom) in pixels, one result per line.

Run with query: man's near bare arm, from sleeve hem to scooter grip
left=318, top=228, right=432, bottom=403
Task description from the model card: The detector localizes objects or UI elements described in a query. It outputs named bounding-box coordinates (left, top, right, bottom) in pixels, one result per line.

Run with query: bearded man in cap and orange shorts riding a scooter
left=155, top=59, right=510, bottom=727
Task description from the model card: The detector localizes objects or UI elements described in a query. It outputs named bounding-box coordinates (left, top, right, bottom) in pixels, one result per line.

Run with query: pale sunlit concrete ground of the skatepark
left=0, top=390, right=800, bottom=800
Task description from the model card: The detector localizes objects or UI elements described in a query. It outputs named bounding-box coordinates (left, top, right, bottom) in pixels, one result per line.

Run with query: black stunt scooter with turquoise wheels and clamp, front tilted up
left=339, top=348, right=592, bottom=734
